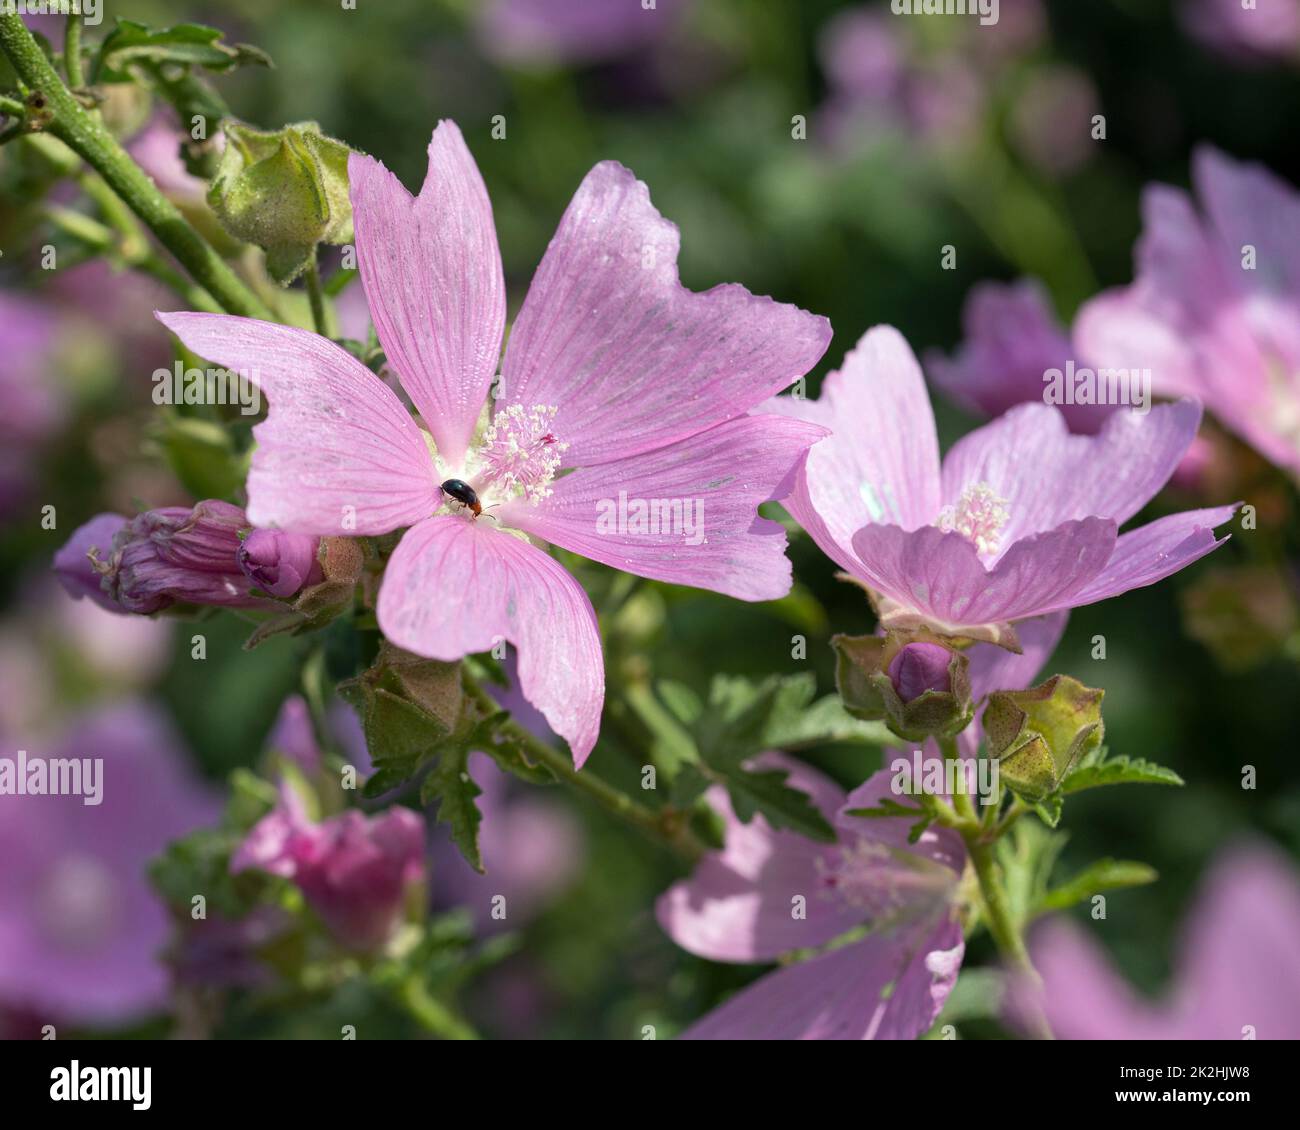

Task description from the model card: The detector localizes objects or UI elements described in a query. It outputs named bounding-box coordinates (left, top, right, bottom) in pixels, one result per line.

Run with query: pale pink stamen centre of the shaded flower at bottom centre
left=818, top=836, right=957, bottom=921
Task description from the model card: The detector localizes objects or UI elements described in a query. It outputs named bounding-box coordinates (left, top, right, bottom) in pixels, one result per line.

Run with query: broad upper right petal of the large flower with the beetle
left=503, top=161, right=831, bottom=467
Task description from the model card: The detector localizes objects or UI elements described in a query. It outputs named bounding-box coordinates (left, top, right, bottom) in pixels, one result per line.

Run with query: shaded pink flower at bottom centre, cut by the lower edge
left=655, top=614, right=1066, bottom=1040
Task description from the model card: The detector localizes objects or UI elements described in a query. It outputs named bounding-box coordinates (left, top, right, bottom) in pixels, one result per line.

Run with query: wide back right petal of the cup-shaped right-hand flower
left=944, top=401, right=1201, bottom=549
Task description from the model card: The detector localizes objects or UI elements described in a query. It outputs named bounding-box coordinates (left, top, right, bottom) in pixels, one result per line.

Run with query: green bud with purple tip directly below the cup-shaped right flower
left=831, top=632, right=974, bottom=741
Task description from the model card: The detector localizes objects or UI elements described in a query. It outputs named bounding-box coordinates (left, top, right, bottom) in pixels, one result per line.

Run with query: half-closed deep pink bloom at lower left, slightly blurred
left=230, top=784, right=425, bottom=952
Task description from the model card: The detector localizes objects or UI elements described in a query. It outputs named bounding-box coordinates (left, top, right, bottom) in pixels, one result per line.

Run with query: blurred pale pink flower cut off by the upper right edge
left=1075, top=147, right=1300, bottom=475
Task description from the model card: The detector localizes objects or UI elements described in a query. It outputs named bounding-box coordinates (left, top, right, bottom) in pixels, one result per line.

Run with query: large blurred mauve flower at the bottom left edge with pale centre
left=0, top=702, right=220, bottom=1025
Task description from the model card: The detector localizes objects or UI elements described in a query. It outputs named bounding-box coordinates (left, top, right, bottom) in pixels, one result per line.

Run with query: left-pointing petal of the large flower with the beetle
left=156, top=313, right=441, bottom=536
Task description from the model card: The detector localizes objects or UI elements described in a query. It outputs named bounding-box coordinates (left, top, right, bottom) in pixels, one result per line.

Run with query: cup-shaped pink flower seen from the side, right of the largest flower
left=764, top=326, right=1235, bottom=649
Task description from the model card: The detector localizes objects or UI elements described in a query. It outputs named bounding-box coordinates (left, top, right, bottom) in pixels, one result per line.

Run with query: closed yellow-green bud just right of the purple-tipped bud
left=982, top=675, right=1105, bottom=804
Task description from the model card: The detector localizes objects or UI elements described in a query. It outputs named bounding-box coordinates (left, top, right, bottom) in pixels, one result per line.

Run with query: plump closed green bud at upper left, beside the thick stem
left=208, top=122, right=352, bottom=286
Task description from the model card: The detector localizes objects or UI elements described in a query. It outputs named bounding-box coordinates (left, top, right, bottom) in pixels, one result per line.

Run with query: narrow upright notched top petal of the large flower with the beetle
left=347, top=121, right=506, bottom=467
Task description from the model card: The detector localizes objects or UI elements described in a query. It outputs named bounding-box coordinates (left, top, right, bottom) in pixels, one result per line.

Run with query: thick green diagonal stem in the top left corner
left=0, top=13, right=272, bottom=319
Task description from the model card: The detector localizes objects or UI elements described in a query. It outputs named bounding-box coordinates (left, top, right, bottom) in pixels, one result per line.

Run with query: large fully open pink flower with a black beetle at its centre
left=159, top=122, right=831, bottom=765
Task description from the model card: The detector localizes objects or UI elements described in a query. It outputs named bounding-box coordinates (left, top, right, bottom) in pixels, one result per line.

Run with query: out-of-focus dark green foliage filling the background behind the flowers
left=0, top=0, right=1300, bottom=1039
